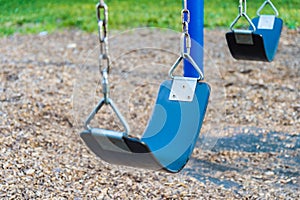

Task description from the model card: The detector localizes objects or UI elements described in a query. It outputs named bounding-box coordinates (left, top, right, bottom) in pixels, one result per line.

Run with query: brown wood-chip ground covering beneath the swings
left=0, top=28, right=300, bottom=199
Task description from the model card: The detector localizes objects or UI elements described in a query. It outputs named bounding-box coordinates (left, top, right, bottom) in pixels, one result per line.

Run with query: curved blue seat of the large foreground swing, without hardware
left=80, top=80, right=210, bottom=173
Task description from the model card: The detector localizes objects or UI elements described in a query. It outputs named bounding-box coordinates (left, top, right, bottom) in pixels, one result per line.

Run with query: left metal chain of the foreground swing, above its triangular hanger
left=96, top=0, right=110, bottom=103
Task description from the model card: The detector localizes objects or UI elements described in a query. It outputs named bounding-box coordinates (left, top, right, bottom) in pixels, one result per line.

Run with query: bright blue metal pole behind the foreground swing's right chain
left=183, top=0, right=204, bottom=77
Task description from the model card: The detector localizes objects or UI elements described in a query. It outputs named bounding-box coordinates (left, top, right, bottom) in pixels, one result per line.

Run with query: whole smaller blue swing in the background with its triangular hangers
left=226, top=0, right=283, bottom=62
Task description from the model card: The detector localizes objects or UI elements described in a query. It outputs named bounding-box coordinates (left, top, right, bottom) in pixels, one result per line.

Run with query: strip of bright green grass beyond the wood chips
left=0, top=0, right=300, bottom=36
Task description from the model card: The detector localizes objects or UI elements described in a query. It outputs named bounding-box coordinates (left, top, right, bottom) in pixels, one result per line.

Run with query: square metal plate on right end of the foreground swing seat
left=169, top=77, right=197, bottom=102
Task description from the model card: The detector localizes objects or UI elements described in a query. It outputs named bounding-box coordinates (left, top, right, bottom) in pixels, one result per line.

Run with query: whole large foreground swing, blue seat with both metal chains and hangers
left=80, top=0, right=210, bottom=173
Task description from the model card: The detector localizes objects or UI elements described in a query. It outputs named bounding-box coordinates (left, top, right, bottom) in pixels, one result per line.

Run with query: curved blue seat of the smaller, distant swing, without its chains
left=226, top=15, right=283, bottom=62
